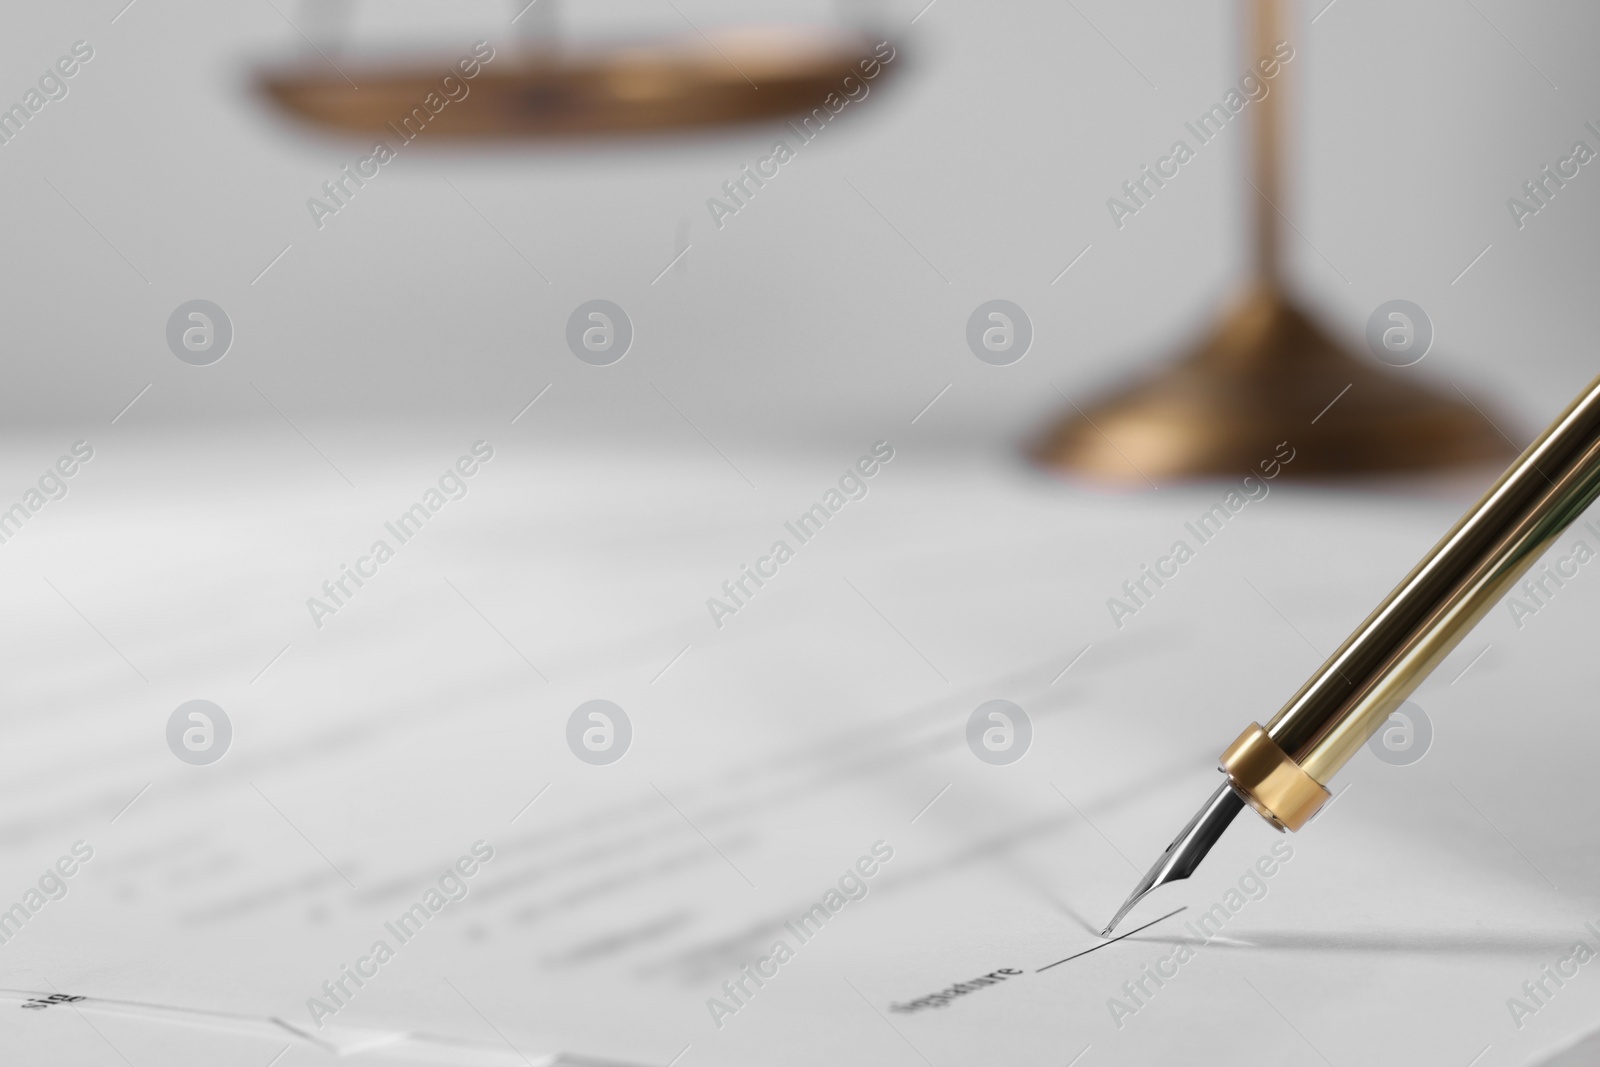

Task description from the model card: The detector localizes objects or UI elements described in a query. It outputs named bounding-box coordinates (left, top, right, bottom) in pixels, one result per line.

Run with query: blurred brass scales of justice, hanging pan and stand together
left=258, top=0, right=1512, bottom=485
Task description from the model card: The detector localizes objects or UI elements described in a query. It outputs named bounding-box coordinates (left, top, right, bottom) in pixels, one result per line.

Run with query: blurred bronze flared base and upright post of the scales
left=1032, top=0, right=1514, bottom=485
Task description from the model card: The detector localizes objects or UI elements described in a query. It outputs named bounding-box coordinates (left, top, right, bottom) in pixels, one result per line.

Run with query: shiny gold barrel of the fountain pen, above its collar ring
left=1224, top=367, right=1600, bottom=784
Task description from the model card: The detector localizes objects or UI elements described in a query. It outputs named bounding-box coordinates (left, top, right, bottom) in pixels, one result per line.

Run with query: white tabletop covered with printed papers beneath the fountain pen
left=0, top=435, right=1600, bottom=1067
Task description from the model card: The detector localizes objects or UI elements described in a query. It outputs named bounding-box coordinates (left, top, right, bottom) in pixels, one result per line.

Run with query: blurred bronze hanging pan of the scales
left=258, top=27, right=904, bottom=141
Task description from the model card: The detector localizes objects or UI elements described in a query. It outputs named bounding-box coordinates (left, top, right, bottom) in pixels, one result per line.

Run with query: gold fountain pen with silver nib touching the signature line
left=1101, top=378, right=1600, bottom=937
